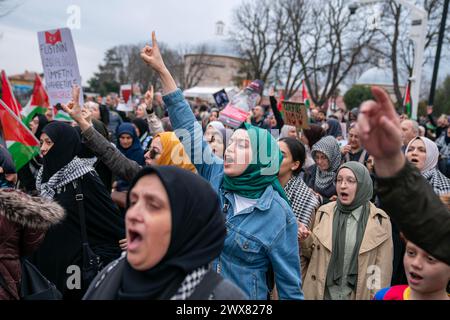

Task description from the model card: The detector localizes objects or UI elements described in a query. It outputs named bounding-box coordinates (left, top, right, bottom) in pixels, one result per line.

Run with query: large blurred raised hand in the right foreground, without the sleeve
left=357, top=87, right=405, bottom=176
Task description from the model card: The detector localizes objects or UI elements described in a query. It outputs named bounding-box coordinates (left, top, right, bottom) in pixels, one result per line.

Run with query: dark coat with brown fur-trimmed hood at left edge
left=0, top=190, right=64, bottom=300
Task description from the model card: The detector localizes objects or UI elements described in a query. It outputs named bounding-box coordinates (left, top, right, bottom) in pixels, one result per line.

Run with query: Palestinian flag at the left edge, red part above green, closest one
left=0, top=99, right=39, bottom=171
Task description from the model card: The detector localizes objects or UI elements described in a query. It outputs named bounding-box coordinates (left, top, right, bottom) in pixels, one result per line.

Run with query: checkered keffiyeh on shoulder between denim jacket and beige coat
left=284, top=176, right=320, bottom=226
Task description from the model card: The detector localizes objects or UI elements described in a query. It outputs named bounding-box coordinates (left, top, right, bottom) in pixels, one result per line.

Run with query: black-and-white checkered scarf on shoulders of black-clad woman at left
left=36, top=157, right=97, bottom=200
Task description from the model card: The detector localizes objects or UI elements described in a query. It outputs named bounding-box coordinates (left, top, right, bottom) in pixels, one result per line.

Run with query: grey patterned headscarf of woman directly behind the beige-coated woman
left=311, top=136, right=341, bottom=190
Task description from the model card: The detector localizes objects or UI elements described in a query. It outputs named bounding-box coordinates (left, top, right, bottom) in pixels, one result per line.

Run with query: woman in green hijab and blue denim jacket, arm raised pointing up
left=135, top=33, right=303, bottom=300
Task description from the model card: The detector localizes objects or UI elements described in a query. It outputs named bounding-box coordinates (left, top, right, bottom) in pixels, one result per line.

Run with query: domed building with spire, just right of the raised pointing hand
left=184, top=21, right=246, bottom=100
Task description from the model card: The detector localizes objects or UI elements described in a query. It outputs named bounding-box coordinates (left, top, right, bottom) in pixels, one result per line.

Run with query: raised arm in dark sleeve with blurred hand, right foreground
left=358, top=87, right=450, bottom=265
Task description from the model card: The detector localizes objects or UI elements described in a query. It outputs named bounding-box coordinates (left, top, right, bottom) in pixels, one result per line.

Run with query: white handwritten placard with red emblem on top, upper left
left=38, top=28, right=83, bottom=106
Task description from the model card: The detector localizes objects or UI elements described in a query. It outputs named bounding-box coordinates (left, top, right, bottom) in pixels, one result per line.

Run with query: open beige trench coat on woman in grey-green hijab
left=301, top=202, right=393, bottom=300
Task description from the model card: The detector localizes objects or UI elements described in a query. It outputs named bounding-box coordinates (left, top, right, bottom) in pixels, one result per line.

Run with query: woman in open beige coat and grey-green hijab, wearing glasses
left=301, top=162, right=393, bottom=300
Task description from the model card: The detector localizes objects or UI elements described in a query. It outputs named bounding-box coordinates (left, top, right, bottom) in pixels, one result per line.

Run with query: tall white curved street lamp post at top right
left=349, top=0, right=428, bottom=120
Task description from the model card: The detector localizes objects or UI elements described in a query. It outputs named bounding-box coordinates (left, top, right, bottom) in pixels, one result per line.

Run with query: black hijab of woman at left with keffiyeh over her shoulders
left=42, top=121, right=81, bottom=183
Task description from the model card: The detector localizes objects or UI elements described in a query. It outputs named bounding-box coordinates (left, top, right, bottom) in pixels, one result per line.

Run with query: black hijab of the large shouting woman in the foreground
left=118, top=166, right=226, bottom=300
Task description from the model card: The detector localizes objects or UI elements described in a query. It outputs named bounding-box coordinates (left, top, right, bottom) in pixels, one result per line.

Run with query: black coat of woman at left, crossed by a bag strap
left=32, top=171, right=125, bottom=300
